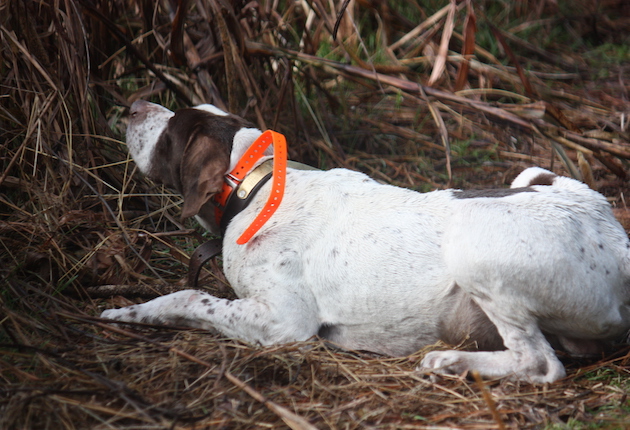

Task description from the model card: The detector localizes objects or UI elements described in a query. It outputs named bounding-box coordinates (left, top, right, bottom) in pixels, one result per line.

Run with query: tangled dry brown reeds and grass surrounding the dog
left=0, top=0, right=630, bottom=429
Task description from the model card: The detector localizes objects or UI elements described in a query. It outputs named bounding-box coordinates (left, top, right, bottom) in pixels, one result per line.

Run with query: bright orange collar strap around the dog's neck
left=214, top=130, right=287, bottom=245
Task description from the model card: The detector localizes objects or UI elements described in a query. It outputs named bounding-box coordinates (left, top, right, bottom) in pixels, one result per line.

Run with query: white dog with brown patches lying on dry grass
left=102, top=101, right=630, bottom=383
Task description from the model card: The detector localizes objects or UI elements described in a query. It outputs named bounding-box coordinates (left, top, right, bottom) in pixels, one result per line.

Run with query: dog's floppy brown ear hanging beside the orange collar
left=180, top=135, right=230, bottom=219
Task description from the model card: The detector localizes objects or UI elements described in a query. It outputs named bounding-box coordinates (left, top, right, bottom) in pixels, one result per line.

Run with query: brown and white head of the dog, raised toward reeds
left=127, top=100, right=261, bottom=218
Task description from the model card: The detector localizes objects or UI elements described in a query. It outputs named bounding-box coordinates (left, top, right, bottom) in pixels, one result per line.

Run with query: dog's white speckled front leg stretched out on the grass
left=101, top=290, right=318, bottom=345
